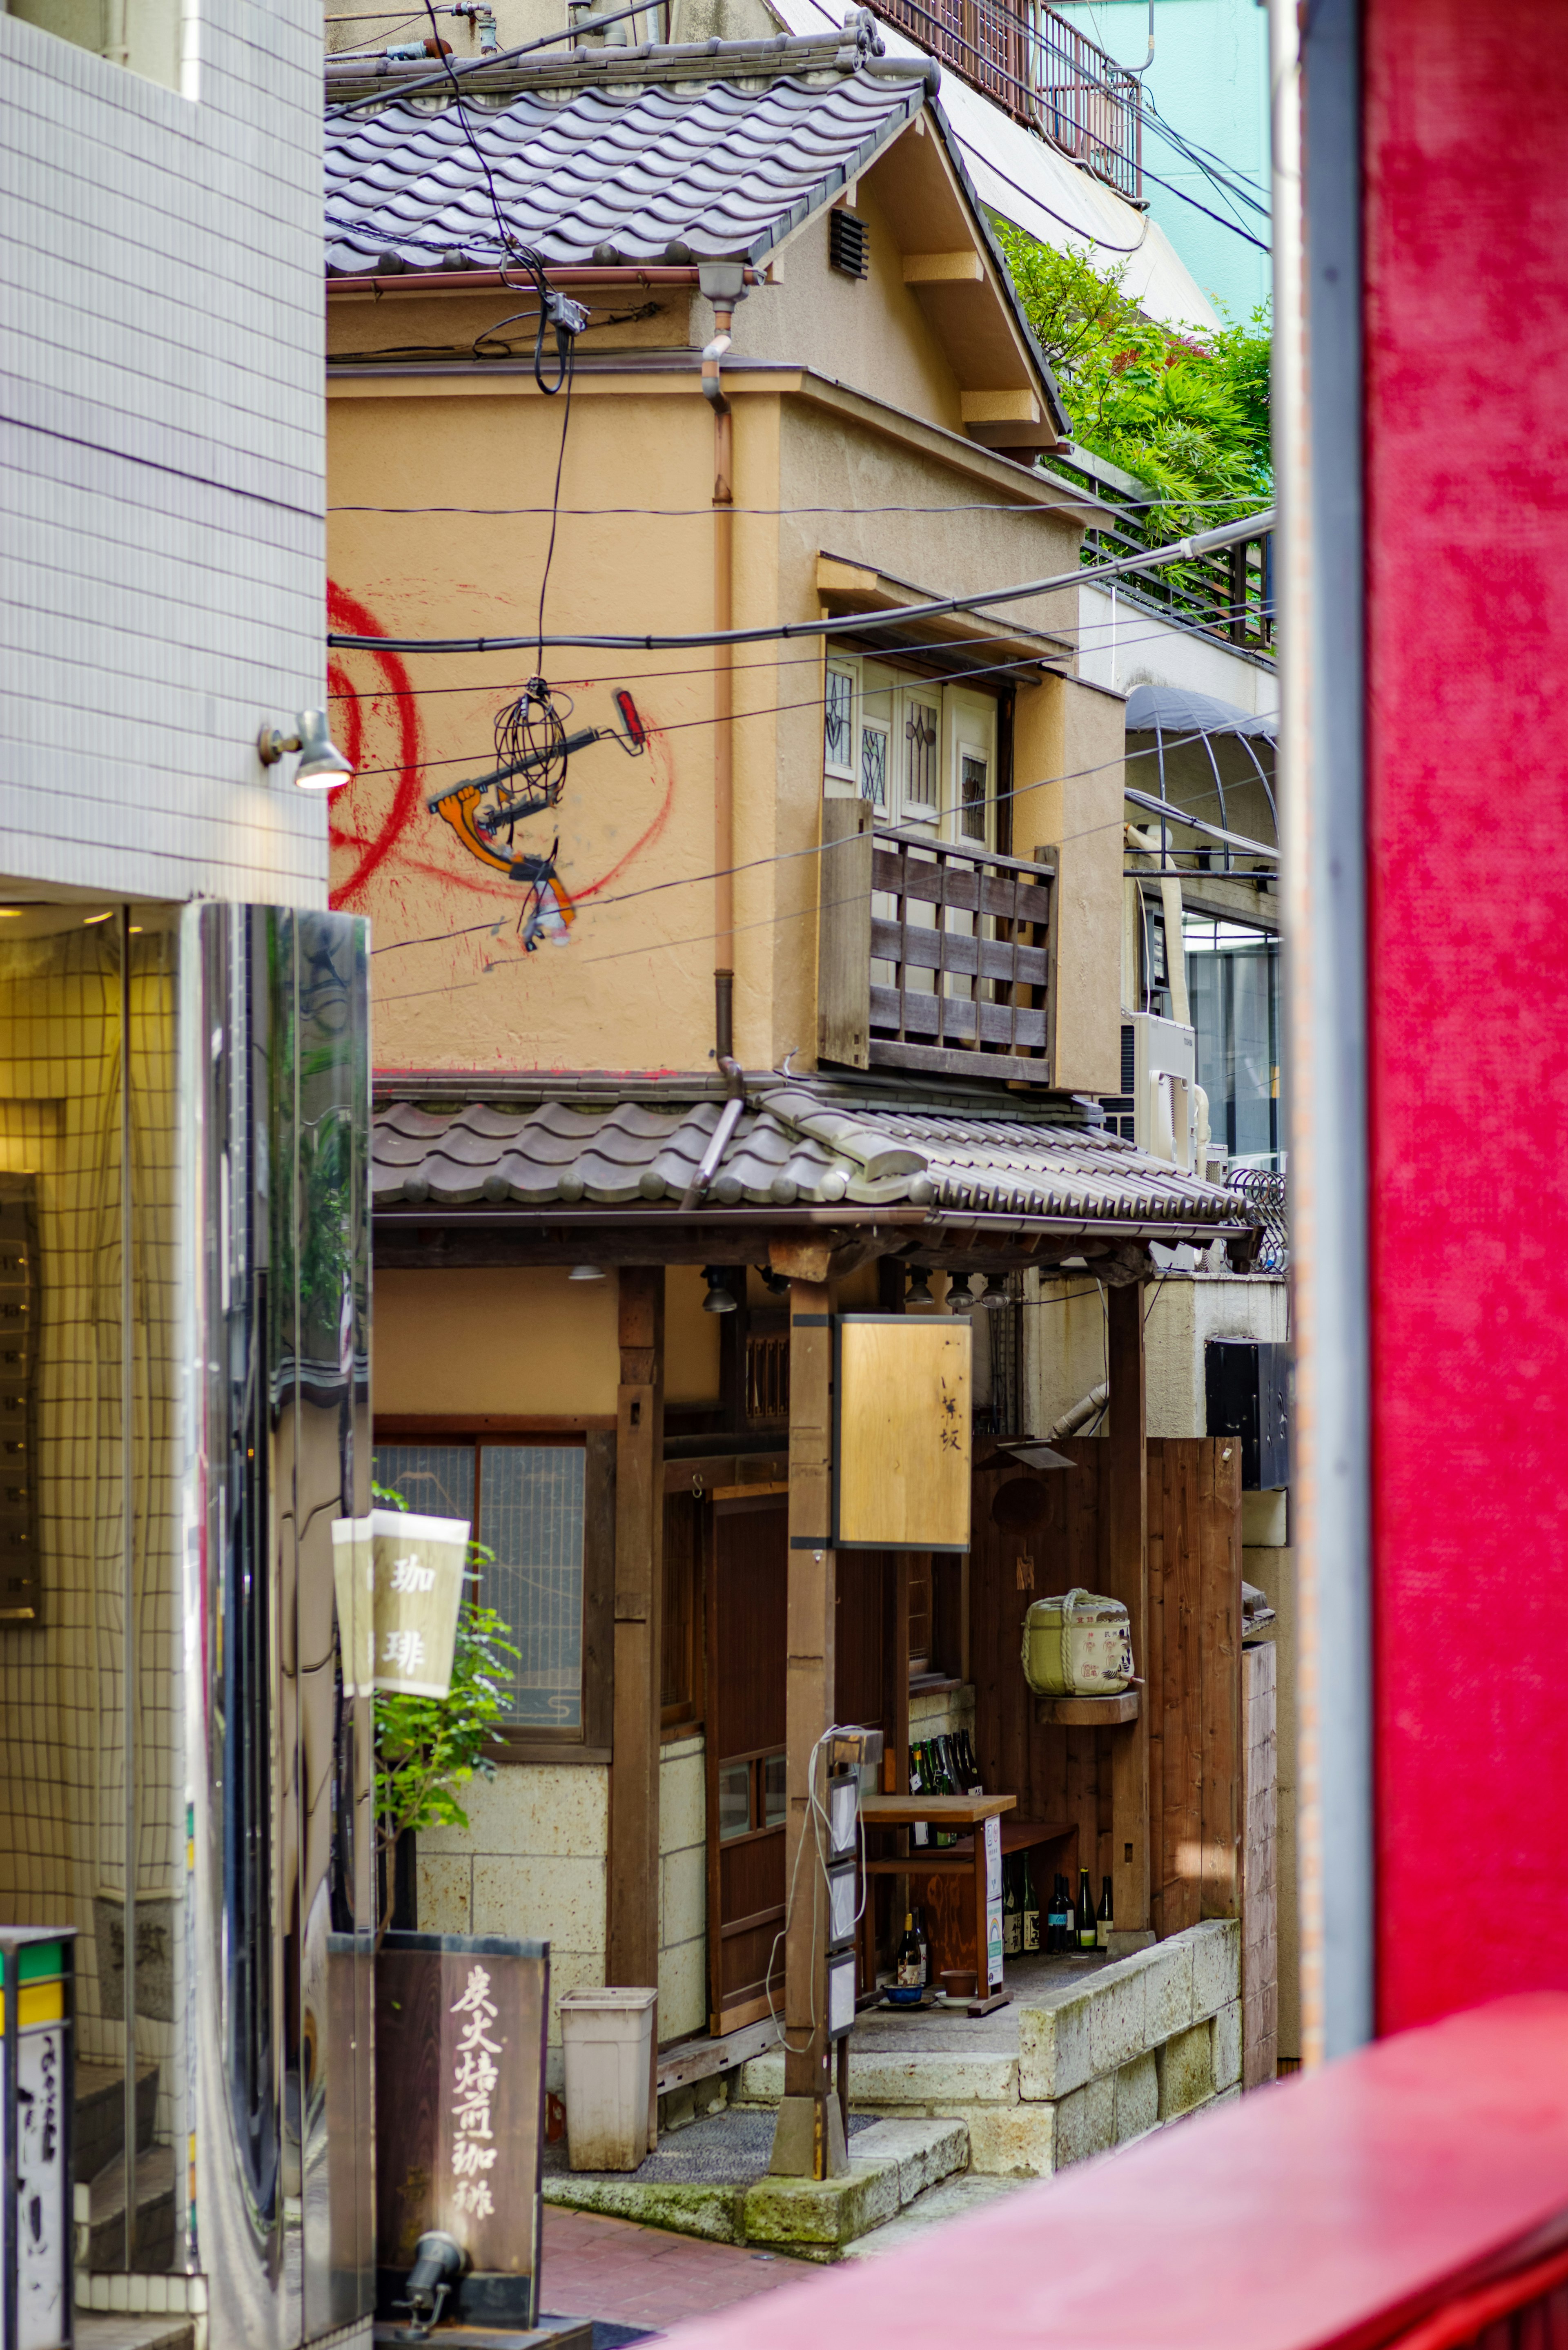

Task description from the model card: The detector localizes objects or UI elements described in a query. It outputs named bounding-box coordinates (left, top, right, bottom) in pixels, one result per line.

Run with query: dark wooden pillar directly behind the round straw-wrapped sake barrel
left=1105, top=1281, right=1152, bottom=1948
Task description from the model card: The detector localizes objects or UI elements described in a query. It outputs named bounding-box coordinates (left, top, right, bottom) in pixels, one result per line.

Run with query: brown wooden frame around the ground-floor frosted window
left=372, top=1412, right=616, bottom=1763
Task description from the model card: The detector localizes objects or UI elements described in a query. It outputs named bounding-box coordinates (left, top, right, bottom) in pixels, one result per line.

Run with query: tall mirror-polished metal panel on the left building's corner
left=181, top=905, right=374, bottom=2350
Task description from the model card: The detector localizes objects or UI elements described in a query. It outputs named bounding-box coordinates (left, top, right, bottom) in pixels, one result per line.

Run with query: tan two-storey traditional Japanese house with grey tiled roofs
left=327, top=19, right=1258, bottom=2181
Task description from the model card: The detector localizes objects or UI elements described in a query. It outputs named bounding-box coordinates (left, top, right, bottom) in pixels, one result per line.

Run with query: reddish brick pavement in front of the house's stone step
left=543, top=2204, right=825, bottom=2334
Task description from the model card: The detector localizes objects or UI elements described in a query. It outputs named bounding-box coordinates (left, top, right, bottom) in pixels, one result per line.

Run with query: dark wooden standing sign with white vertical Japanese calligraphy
left=376, top=1934, right=550, bottom=2326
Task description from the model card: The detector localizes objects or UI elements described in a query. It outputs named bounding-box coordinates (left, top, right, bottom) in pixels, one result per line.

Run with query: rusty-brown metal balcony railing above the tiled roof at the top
left=877, top=0, right=1143, bottom=202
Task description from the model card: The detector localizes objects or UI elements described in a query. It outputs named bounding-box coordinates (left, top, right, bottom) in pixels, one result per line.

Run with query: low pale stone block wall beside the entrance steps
left=736, top=1917, right=1241, bottom=2178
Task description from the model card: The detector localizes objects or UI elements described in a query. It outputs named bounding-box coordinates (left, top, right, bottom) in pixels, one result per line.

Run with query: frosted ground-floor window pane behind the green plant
left=479, top=1445, right=588, bottom=1730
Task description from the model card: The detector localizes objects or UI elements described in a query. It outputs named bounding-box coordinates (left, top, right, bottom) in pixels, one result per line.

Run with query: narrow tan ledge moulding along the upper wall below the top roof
left=327, top=348, right=1112, bottom=529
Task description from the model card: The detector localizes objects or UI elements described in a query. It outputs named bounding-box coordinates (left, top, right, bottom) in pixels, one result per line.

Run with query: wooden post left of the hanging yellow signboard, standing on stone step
left=771, top=1281, right=849, bottom=2178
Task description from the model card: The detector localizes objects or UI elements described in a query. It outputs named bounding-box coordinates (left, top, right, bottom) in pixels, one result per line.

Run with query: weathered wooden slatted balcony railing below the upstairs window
left=816, top=799, right=1056, bottom=1086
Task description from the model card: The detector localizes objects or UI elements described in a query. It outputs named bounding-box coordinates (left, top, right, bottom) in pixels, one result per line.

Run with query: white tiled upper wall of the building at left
left=0, top=0, right=327, bottom=905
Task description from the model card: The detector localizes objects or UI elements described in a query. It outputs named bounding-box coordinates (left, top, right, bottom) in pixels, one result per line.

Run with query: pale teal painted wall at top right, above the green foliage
left=1051, top=0, right=1270, bottom=320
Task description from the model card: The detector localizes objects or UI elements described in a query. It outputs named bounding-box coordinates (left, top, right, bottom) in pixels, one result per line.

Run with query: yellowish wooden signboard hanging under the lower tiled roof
left=832, top=1313, right=973, bottom=1551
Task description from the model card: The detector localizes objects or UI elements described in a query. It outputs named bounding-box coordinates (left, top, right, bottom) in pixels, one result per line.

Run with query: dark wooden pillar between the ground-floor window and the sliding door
left=604, top=1264, right=665, bottom=1983
